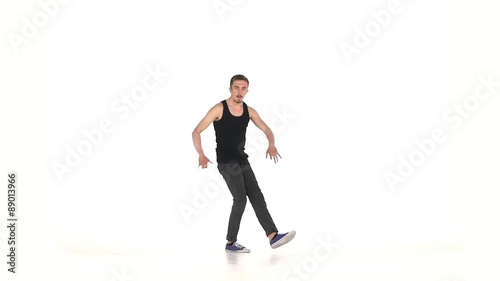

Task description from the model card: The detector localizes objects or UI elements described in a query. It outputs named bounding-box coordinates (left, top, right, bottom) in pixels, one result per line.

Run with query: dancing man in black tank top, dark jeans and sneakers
left=193, top=74, right=295, bottom=253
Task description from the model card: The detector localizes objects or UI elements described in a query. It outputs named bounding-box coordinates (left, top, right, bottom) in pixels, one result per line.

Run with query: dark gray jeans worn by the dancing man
left=217, top=163, right=278, bottom=241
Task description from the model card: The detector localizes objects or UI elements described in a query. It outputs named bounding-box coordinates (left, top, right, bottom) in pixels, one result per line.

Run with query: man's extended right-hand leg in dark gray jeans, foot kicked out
left=241, top=164, right=278, bottom=239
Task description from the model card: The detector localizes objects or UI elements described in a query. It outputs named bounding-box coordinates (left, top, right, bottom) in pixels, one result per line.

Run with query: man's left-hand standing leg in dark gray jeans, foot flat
left=217, top=163, right=247, bottom=242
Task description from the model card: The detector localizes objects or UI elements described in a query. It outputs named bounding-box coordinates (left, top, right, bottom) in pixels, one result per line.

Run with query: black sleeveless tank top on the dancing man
left=213, top=100, right=250, bottom=164
